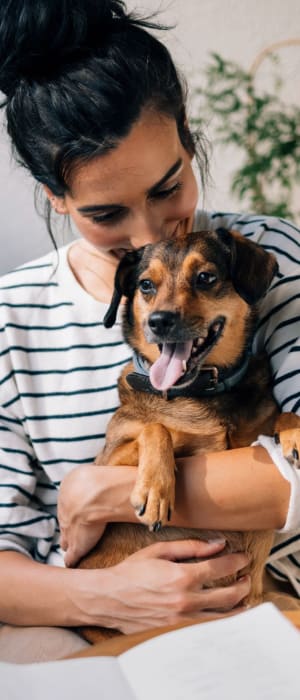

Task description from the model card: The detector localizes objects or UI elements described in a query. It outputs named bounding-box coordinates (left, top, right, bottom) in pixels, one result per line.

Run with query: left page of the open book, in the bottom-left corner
left=0, top=656, right=136, bottom=700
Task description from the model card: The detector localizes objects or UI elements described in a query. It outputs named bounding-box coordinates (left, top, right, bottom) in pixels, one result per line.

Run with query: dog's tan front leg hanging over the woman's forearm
left=131, top=423, right=175, bottom=531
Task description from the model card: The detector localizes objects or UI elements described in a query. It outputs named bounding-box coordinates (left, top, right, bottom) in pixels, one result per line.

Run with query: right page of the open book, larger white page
left=119, top=603, right=300, bottom=700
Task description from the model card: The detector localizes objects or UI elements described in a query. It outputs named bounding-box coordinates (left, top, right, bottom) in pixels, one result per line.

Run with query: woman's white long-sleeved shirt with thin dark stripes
left=0, top=212, right=300, bottom=593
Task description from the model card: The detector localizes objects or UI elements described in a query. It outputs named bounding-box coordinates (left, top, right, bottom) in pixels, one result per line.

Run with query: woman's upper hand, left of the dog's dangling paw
left=57, top=464, right=136, bottom=566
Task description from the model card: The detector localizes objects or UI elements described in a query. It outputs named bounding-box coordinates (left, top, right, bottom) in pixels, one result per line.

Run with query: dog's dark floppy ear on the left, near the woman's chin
left=103, top=248, right=144, bottom=328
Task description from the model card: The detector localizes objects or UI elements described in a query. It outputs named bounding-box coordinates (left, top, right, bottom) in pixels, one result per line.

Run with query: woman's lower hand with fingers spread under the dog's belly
left=88, top=540, right=250, bottom=634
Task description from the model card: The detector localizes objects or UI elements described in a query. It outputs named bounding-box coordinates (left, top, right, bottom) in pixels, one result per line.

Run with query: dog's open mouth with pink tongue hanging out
left=150, top=316, right=225, bottom=391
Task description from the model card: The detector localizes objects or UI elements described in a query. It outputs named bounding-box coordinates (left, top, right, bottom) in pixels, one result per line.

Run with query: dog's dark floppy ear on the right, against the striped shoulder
left=217, top=228, right=278, bottom=305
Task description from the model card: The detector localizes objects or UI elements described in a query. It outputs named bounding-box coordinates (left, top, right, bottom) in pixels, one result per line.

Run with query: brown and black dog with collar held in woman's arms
left=79, top=229, right=300, bottom=641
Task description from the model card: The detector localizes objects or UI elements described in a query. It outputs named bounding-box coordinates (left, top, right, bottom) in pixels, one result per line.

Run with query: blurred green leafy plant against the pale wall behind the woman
left=192, top=39, right=300, bottom=219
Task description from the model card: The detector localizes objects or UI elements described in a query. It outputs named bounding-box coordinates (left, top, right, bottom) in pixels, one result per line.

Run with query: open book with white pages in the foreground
left=0, top=603, right=300, bottom=700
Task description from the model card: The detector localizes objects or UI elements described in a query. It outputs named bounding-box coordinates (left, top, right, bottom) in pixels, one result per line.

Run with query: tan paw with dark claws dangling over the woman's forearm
left=130, top=476, right=175, bottom=532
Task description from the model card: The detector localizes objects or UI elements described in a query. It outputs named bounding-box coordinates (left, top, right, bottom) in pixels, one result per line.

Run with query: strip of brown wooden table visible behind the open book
left=67, top=610, right=300, bottom=659
